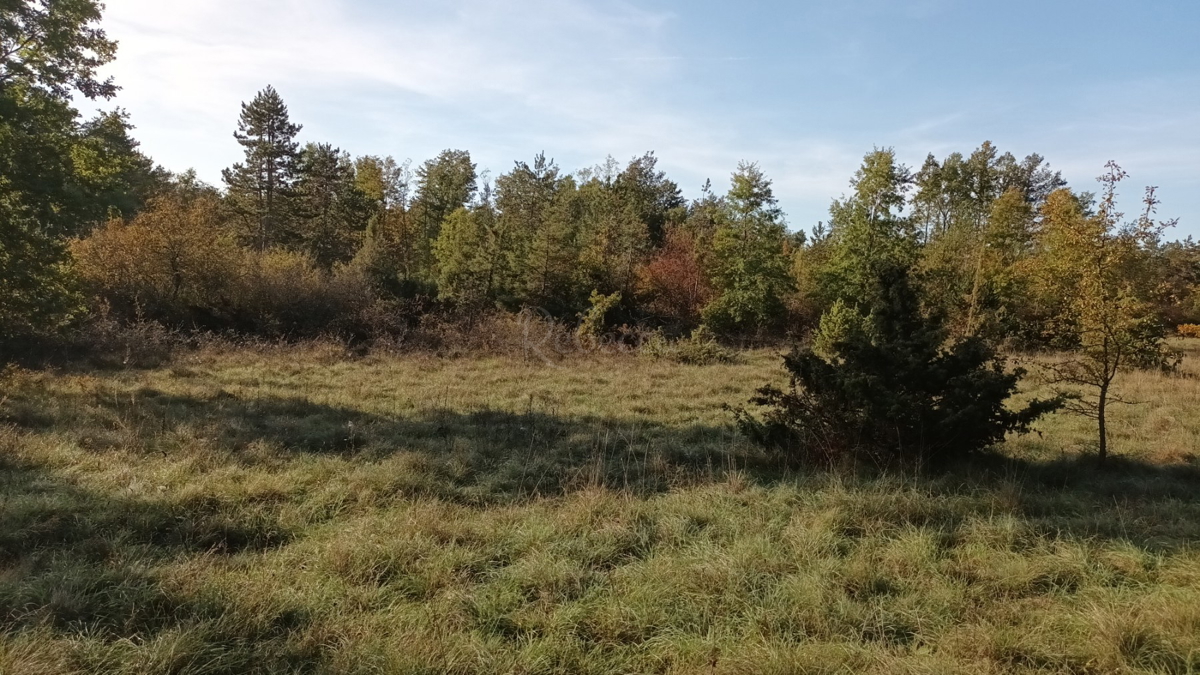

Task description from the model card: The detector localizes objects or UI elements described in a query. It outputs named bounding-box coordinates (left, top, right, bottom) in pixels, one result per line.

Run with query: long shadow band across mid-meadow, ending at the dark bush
left=0, top=389, right=748, bottom=504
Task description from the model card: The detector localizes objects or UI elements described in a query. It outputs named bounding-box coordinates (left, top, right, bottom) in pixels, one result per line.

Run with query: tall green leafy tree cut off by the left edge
left=0, top=0, right=133, bottom=338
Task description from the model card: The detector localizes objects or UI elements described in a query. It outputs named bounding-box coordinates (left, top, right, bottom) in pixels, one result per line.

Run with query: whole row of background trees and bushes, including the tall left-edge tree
left=0, top=0, right=1200, bottom=348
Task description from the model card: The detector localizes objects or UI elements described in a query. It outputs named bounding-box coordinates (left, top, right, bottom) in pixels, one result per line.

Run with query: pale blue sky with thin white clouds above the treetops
left=96, top=0, right=1200, bottom=237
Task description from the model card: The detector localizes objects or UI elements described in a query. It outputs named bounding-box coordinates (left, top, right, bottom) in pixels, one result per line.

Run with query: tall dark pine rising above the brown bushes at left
left=222, top=85, right=302, bottom=250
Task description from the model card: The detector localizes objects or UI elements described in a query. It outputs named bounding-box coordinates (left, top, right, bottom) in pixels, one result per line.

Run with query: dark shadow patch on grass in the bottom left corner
left=0, top=453, right=320, bottom=674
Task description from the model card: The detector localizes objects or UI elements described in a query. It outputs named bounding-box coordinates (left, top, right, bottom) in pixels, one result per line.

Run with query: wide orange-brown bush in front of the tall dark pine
left=72, top=197, right=388, bottom=338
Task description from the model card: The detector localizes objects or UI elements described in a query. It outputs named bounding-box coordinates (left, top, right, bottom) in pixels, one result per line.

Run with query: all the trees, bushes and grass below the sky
left=0, top=0, right=1200, bottom=675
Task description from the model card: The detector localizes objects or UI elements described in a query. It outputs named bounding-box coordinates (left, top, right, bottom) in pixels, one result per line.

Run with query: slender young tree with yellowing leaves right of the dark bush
left=1036, top=162, right=1175, bottom=462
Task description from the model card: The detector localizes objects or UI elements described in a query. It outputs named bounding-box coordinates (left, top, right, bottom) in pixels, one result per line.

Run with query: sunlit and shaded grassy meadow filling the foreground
left=0, top=347, right=1200, bottom=675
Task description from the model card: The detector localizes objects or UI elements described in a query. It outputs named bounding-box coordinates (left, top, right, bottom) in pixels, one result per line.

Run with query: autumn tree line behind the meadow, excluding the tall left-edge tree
left=51, top=88, right=1200, bottom=347
